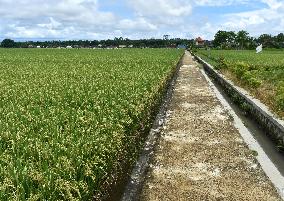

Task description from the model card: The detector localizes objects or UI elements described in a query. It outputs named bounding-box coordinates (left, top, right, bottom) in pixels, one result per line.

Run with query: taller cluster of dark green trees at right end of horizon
left=212, top=30, right=284, bottom=49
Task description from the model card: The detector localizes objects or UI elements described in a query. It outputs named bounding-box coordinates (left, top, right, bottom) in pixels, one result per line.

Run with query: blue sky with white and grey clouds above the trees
left=0, top=0, right=284, bottom=40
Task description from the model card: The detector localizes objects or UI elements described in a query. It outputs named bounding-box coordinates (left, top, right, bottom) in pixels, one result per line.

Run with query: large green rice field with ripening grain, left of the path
left=0, top=49, right=183, bottom=200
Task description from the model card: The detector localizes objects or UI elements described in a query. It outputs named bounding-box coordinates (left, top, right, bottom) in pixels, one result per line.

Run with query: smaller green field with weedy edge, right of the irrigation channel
left=197, top=50, right=284, bottom=118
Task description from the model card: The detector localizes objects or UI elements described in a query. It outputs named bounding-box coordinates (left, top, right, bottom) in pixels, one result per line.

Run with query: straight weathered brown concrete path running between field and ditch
left=140, top=53, right=281, bottom=201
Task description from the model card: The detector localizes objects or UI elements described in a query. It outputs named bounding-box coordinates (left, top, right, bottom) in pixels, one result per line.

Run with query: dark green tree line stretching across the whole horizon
left=0, top=30, right=284, bottom=49
